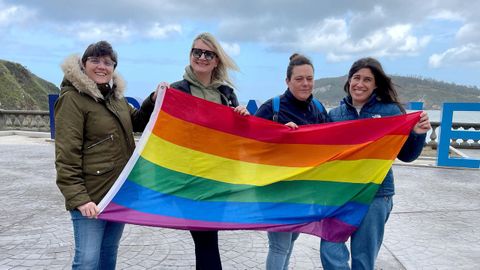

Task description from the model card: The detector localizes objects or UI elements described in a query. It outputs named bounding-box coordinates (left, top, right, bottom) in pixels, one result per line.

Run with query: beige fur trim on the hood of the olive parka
left=61, top=55, right=126, bottom=101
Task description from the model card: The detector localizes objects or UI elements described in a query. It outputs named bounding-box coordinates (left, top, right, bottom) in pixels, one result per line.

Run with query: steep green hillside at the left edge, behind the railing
left=0, top=60, right=59, bottom=110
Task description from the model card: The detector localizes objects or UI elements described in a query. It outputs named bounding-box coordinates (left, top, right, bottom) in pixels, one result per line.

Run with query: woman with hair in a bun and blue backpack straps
left=255, top=54, right=328, bottom=270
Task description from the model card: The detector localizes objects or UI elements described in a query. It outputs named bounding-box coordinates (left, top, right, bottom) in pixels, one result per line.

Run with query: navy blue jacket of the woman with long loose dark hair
left=328, top=94, right=426, bottom=197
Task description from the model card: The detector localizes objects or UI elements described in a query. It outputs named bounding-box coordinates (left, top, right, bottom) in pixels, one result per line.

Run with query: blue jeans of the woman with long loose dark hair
left=320, top=196, right=393, bottom=270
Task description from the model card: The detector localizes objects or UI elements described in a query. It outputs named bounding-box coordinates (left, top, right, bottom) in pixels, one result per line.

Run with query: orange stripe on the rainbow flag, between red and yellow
left=153, top=111, right=407, bottom=167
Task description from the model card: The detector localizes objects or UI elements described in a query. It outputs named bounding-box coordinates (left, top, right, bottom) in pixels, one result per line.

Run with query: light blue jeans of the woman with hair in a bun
left=267, top=232, right=300, bottom=270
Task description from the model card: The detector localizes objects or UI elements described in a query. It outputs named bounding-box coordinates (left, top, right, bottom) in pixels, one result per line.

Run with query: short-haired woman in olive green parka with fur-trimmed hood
left=55, top=41, right=156, bottom=269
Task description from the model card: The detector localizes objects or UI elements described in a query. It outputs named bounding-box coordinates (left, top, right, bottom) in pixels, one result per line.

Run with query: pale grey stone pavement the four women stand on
left=0, top=135, right=480, bottom=270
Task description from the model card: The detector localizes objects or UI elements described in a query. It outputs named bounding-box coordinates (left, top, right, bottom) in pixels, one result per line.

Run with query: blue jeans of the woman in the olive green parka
left=70, top=210, right=125, bottom=270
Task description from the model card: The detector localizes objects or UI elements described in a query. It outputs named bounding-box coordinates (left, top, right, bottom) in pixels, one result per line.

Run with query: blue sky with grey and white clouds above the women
left=0, top=0, right=480, bottom=101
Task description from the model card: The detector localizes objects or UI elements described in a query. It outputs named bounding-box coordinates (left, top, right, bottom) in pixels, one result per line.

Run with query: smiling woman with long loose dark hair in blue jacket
left=320, top=58, right=431, bottom=270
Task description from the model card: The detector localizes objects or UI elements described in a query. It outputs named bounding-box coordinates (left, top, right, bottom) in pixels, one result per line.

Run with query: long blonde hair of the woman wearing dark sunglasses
left=192, top=32, right=239, bottom=87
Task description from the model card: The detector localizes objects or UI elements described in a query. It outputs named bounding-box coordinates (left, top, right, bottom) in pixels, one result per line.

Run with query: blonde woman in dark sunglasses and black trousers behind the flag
left=171, top=33, right=249, bottom=270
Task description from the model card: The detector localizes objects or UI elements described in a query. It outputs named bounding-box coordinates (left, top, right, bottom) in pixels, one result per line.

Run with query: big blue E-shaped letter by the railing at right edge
left=437, top=103, right=480, bottom=168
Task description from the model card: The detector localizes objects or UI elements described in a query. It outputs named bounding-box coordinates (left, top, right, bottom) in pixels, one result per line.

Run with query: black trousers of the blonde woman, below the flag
left=190, top=231, right=222, bottom=270
